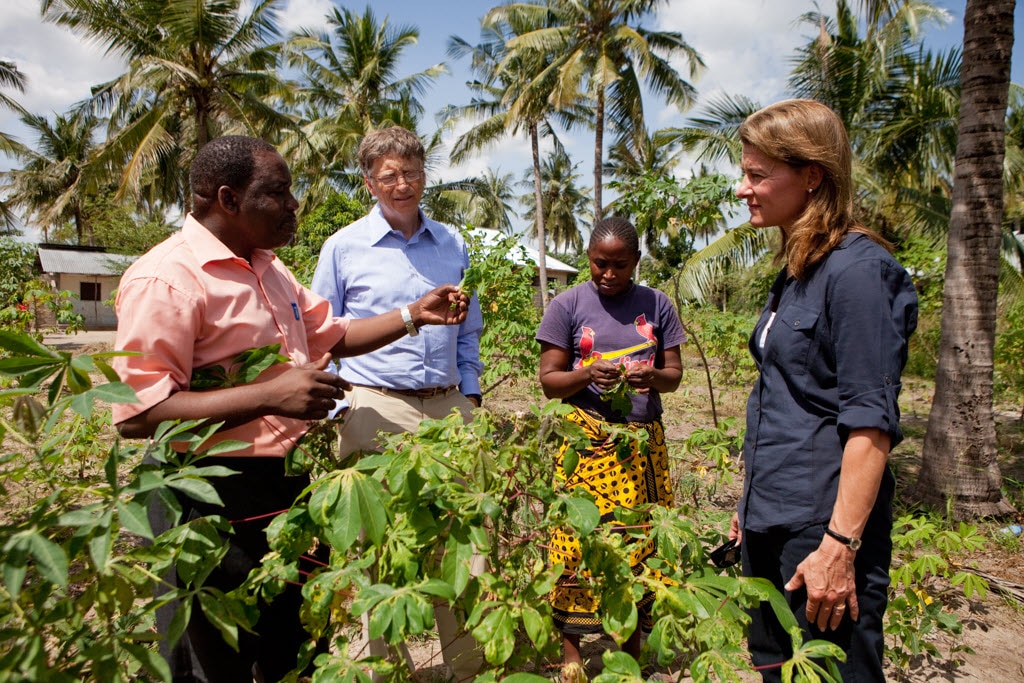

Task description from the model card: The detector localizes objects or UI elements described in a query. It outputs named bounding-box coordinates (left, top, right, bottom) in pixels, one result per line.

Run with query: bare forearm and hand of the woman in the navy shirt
left=785, top=429, right=890, bottom=630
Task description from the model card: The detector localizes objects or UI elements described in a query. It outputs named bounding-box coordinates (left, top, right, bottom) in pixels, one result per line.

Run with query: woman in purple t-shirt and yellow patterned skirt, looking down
left=537, top=217, right=686, bottom=680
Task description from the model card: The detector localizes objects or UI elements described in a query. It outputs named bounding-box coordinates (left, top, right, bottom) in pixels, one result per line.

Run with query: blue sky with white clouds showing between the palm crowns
left=0, top=0, right=1024, bottom=236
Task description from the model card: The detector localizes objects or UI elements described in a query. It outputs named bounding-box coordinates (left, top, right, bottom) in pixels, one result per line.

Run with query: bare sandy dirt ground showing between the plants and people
left=29, top=332, right=1024, bottom=683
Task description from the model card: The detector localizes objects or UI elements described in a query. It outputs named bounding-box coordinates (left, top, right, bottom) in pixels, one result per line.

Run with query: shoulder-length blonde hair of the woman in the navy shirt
left=739, top=99, right=892, bottom=280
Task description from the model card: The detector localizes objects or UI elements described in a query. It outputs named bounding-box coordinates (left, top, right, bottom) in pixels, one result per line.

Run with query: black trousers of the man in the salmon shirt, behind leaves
left=150, top=457, right=310, bottom=683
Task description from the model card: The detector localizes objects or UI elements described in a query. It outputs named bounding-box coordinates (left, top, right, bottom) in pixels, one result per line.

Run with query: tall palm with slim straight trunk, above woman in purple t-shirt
left=493, top=0, right=703, bottom=221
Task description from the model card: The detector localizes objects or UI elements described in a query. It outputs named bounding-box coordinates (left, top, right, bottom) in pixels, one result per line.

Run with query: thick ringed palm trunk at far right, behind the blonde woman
left=915, top=0, right=1015, bottom=519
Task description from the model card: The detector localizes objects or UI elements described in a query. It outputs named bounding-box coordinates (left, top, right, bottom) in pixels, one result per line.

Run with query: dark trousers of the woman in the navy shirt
left=742, top=504, right=892, bottom=683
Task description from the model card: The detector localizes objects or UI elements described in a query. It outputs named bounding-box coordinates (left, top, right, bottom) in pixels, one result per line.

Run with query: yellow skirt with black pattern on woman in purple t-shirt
left=548, top=408, right=673, bottom=634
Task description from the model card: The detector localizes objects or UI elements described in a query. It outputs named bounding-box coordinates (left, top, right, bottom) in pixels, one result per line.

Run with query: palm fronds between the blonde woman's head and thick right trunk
left=790, top=0, right=959, bottom=233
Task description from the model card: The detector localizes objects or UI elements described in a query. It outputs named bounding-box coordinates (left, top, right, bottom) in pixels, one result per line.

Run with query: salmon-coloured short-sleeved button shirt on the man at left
left=112, top=214, right=348, bottom=457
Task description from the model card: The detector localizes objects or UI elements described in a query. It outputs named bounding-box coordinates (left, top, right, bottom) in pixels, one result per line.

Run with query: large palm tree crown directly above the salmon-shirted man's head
left=41, top=0, right=293, bottom=205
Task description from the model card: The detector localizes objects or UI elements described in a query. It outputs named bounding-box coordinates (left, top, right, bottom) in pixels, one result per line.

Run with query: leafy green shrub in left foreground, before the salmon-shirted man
left=0, top=331, right=247, bottom=683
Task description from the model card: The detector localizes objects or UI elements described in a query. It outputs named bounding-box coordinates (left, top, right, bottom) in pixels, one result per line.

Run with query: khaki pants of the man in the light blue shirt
left=338, top=386, right=486, bottom=681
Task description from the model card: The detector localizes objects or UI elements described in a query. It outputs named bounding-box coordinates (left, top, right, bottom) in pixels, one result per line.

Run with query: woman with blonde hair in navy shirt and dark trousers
left=730, top=99, right=918, bottom=681
